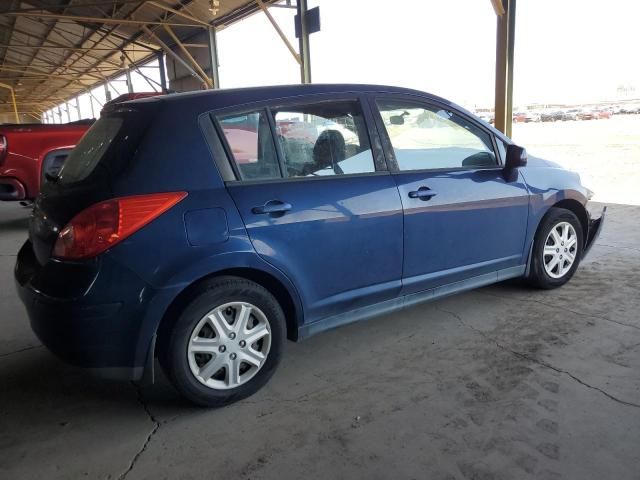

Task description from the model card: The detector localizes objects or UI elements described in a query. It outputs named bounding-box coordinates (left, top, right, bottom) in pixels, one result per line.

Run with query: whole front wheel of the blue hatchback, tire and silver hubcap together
left=528, top=207, right=584, bottom=289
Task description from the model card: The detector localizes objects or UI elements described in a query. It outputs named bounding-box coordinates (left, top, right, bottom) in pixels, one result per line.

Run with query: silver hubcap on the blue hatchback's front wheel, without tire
left=542, top=222, right=578, bottom=278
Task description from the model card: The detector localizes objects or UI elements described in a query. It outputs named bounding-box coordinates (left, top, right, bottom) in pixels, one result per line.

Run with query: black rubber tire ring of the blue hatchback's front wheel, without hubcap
left=529, top=207, right=584, bottom=289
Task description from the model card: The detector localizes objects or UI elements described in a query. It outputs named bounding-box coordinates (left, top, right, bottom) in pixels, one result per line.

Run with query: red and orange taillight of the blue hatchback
left=53, top=192, right=187, bottom=260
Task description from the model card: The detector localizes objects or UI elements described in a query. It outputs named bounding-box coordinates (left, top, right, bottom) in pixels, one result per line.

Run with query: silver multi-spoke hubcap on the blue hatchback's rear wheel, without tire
left=187, top=302, right=271, bottom=390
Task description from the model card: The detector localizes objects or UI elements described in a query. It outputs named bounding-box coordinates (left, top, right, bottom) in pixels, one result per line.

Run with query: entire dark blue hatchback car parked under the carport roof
left=15, top=85, right=604, bottom=406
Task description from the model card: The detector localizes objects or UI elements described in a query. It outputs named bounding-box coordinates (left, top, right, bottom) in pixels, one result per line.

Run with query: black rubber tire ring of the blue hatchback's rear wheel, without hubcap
left=162, top=277, right=286, bottom=407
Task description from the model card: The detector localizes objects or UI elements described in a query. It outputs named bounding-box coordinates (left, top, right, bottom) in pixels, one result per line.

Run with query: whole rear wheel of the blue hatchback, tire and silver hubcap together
left=160, top=276, right=286, bottom=407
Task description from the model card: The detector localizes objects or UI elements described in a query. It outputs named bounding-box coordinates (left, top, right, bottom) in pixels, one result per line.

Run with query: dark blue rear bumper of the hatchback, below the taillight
left=15, top=242, right=151, bottom=380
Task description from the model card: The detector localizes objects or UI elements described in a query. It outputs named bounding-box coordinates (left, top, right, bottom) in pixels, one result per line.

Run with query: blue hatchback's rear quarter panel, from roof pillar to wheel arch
left=107, top=104, right=303, bottom=364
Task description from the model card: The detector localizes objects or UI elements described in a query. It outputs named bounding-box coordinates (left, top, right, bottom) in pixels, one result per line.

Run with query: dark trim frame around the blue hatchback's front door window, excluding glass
left=367, top=93, right=504, bottom=174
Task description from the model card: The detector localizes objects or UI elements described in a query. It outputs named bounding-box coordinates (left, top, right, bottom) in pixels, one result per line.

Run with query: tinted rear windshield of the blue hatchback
left=56, top=109, right=148, bottom=184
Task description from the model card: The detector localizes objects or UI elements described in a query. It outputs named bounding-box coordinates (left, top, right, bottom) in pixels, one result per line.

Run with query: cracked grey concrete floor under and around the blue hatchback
left=0, top=204, right=640, bottom=480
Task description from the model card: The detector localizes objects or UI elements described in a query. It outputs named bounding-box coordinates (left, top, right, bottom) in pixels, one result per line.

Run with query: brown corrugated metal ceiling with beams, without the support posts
left=0, top=0, right=275, bottom=116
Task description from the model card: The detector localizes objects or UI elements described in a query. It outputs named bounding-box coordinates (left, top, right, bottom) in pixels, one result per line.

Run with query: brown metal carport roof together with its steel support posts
left=0, top=0, right=516, bottom=134
